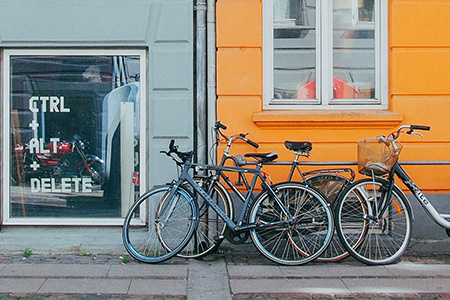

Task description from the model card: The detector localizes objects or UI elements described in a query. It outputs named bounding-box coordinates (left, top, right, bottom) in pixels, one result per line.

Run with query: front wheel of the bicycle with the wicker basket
left=336, top=177, right=412, bottom=265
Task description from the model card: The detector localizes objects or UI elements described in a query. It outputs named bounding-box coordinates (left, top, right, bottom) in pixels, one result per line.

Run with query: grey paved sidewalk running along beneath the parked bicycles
left=0, top=246, right=450, bottom=300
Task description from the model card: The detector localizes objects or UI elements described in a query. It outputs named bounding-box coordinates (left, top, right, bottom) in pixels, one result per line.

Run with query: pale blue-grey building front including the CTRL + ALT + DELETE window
left=0, top=0, right=194, bottom=225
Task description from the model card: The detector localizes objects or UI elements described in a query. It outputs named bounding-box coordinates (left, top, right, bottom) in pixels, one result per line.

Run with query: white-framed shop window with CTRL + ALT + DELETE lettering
left=2, top=50, right=145, bottom=224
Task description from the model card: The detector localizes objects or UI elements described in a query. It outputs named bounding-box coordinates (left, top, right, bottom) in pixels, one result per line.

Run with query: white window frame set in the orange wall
left=262, top=0, right=389, bottom=110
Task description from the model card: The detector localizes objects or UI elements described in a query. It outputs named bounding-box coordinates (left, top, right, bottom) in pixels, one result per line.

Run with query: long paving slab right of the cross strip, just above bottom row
left=230, top=279, right=350, bottom=294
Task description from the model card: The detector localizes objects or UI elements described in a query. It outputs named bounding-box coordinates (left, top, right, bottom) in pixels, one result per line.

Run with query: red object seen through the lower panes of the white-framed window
left=297, top=77, right=361, bottom=99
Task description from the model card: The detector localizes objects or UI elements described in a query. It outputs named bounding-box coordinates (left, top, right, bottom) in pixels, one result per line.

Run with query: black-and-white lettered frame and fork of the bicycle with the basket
left=377, top=162, right=450, bottom=229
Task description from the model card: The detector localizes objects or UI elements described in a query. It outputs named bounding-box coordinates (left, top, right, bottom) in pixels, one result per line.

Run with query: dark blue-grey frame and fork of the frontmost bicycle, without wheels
left=161, top=160, right=294, bottom=232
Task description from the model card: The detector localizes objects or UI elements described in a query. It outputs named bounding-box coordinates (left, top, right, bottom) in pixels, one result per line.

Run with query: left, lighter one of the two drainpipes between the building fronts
left=195, top=0, right=208, bottom=163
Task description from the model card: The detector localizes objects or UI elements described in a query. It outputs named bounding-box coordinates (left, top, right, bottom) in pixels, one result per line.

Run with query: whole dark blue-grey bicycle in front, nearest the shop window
left=122, top=140, right=334, bottom=265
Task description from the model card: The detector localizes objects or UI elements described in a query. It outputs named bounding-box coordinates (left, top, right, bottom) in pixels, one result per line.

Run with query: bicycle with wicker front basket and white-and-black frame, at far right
left=335, top=125, right=450, bottom=265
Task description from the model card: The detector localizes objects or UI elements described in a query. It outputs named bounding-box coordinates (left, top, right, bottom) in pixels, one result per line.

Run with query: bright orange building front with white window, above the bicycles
left=217, top=0, right=450, bottom=193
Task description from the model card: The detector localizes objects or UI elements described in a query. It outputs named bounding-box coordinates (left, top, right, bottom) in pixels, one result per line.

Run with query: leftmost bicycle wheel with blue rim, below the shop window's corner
left=122, top=186, right=198, bottom=263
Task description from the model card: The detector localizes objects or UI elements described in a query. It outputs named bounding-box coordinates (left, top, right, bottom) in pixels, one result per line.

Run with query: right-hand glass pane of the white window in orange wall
left=333, top=0, right=375, bottom=99
